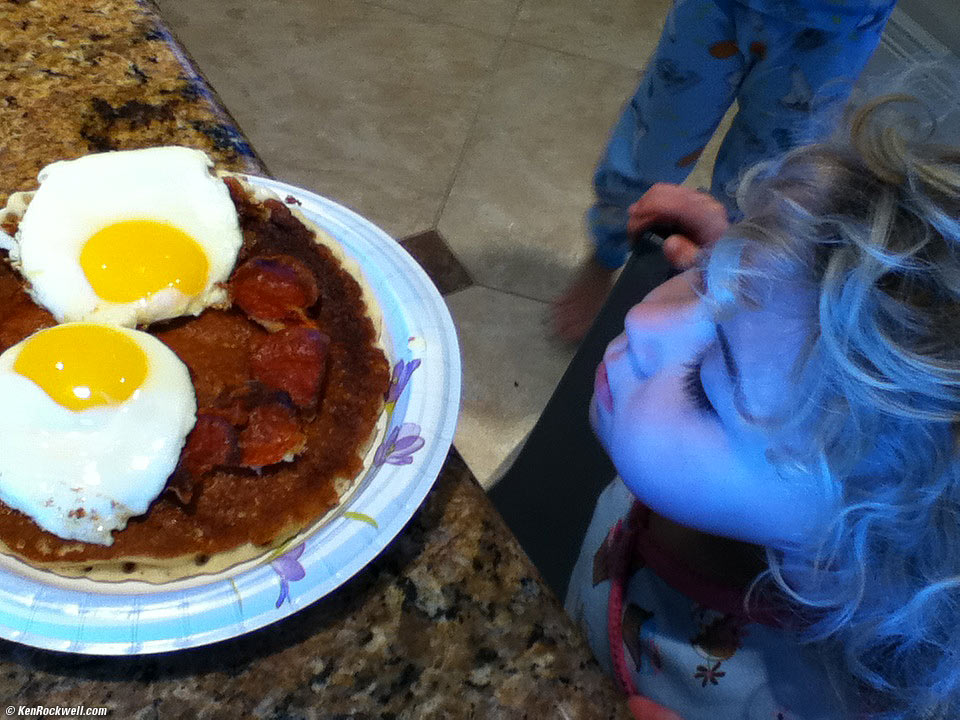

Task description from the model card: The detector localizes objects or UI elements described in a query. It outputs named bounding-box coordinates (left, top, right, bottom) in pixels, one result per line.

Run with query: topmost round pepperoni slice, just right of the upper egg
left=230, top=255, right=320, bottom=322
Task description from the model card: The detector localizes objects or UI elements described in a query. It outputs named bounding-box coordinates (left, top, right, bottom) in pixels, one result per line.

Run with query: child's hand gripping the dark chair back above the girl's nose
left=627, top=183, right=730, bottom=269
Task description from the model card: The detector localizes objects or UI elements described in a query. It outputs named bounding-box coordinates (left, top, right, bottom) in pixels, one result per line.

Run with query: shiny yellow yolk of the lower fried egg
left=13, top=323, right=147, bottom=412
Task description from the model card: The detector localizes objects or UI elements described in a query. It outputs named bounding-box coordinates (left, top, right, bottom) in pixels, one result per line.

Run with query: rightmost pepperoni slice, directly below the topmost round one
left=250, top=326, right=330, bottom=410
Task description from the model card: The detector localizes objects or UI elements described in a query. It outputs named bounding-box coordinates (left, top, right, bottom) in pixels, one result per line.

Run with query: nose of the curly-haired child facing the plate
left=624, top=282, right=714, bottom=376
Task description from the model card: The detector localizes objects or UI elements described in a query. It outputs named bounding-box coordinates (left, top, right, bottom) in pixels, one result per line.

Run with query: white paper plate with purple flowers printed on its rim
left=0, top=176, right=460, bottom=655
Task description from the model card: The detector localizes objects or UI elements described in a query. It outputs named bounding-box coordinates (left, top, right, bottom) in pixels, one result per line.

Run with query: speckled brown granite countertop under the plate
left=0, top=0, right=630, bottom=719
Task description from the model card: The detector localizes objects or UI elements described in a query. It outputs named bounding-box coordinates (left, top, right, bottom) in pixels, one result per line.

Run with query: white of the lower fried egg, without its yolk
left=0, top=328, right=197, bottom=545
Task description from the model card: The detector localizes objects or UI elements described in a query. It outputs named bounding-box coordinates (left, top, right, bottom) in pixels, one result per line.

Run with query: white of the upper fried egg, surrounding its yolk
left=10, top=146, right=243, bottom=327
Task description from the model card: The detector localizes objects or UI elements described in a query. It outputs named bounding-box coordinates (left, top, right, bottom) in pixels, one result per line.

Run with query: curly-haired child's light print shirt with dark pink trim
left=566, top=479, right=843, bottom=720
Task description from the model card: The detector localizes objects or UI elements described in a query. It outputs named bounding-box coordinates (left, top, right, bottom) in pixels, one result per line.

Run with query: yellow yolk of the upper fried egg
left=80, top=220, right=208, bottom=302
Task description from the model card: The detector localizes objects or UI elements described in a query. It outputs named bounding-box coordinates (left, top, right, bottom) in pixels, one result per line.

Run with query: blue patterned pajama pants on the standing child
left=587, top=0, right=893, bottom=268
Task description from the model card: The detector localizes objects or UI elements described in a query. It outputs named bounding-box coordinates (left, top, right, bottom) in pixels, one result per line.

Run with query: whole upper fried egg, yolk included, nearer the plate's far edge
left=10, top=147, right=243, bottom=327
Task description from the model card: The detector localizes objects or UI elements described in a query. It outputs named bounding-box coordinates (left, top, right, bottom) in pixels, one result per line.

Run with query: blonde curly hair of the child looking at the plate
left=704, top=95, right=960, bottom=720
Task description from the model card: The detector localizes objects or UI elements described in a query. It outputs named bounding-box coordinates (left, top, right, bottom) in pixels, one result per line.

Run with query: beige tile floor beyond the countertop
left=157, top=0, right=728, bottom=487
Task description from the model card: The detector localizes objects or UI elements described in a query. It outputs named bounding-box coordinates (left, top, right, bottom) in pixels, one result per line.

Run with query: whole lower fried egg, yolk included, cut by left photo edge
left=0, top=323, right=197, bottom=545
